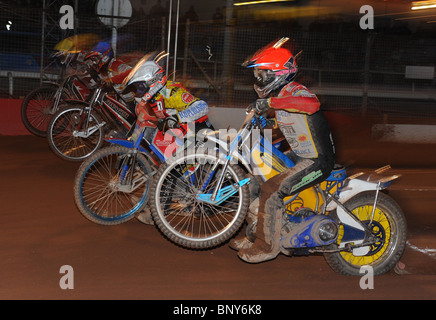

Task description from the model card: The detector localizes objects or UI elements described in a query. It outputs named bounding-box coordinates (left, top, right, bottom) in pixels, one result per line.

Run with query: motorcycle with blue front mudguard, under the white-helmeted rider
left=74, top=105, right=215, bottom=225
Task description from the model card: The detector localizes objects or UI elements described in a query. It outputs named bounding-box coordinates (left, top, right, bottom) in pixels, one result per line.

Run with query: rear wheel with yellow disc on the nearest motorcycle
left=324, top=192, right=407, bottom=276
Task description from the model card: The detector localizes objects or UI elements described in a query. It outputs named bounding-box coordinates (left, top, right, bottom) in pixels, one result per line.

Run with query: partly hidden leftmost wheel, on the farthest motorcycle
left=21, top=85, right=68, bottom=137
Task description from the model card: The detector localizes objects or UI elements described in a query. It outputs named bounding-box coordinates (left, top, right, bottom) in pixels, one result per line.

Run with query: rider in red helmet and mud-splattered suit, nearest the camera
left=230, top=38, right=335, bottom=263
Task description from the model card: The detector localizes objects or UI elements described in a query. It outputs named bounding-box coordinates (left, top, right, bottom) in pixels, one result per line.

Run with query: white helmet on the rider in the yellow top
left=124, top=52, right=167, bottom=101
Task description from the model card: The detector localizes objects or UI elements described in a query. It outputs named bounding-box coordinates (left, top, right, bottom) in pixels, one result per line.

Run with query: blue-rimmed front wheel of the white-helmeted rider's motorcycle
left=74, top=146, right=152, bottom=225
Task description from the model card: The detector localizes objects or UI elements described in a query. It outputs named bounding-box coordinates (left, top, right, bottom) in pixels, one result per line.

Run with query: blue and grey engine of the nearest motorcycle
left=281, top=208, right=339, bottom=249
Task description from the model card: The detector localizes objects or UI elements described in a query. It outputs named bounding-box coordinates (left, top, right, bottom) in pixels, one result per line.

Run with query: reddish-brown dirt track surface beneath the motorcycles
left=0, top=129, right=436, bottom=300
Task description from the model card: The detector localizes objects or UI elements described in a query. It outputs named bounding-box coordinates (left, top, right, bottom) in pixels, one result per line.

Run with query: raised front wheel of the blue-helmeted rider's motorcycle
left=47, top=104, right=104, bottom=161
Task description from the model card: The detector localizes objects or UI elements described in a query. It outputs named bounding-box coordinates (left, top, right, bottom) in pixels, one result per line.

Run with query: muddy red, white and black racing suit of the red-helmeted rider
left=238, top=82, right=335, bottom=263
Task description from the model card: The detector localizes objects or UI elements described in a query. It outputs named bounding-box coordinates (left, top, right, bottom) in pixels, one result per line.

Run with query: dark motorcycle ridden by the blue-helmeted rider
left=47, top=86, right=136, bottom=161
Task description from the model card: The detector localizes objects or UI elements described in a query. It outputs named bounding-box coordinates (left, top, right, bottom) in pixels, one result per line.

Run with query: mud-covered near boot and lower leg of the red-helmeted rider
left=238, top=194, right=283, bottom=263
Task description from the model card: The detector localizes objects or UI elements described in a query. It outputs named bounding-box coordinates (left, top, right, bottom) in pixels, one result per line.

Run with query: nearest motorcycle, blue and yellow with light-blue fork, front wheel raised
left=150, top=111, right=407, bottom=275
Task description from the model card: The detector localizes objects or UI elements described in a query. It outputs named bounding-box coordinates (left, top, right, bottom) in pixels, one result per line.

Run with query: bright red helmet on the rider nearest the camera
left=242, top=38, right=298, bottom=98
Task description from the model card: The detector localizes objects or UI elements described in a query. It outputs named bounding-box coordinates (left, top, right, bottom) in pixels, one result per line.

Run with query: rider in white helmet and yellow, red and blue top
left=123, top=52, right=213, bottom=224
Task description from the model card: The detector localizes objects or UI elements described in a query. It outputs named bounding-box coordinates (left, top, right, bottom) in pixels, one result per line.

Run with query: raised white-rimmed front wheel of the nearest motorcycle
left=152, top=155, right=248, bottom=247
